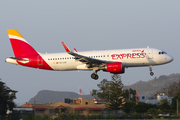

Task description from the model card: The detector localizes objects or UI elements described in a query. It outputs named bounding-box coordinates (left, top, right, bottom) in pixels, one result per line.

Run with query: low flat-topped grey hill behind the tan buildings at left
left=28, top=90, right=93, bottom=104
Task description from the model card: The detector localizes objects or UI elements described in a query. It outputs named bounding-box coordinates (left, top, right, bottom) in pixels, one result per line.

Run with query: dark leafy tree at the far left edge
left=0, top=81, right=17, bottom=115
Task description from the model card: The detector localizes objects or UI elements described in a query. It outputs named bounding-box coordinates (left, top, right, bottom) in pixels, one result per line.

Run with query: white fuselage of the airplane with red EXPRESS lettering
left=40, top=48, right=173, bottom=71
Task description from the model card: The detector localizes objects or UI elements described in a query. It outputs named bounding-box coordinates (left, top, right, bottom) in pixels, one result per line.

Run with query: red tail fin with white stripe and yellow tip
left=7, top=29, right=38, bottom=58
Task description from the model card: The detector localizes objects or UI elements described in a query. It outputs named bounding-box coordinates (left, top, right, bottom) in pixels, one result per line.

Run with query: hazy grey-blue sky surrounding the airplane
left=0, top=0, right=180, bottom=104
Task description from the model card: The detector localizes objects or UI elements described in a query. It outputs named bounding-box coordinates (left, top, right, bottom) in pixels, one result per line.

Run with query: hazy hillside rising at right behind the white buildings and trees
left=124, top=73, right=180, bottom=97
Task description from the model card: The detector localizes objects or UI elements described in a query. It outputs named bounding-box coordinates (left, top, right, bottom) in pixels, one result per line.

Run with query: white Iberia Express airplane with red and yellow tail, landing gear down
left=5, top=29, right=174, bottom=80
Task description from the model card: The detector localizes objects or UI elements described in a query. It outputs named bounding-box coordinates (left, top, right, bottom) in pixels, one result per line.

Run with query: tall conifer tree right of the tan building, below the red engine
left=91, top=74, right=123, bottom=110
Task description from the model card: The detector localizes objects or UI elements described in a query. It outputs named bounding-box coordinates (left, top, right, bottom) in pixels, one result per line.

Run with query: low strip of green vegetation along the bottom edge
left=1, top=113, right=179, bottom=120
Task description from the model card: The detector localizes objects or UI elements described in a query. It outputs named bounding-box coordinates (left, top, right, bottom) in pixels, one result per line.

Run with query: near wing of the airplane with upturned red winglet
left=62, top=42, right=109, bottom=68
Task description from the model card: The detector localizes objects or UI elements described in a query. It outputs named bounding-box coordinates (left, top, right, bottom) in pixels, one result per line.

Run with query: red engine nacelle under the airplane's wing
left=105, top=62, right=125, bottom=74
